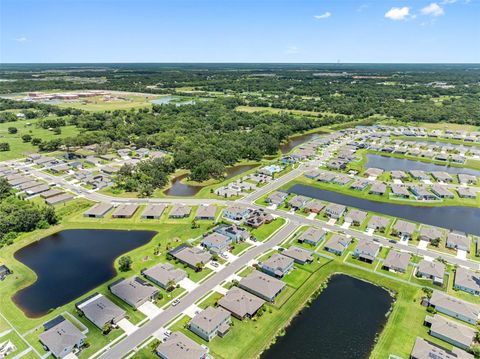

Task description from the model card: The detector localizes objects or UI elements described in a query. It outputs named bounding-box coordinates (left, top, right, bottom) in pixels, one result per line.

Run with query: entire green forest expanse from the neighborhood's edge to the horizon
left=0, top=64, right=480, bottom=187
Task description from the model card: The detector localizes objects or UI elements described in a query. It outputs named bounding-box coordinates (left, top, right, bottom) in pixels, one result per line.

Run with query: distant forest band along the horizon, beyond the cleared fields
left=0, top=64, right=480, bottom=124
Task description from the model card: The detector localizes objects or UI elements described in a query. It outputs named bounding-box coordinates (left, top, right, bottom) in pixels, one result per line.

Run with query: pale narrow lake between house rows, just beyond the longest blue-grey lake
left=364, top=153, right=480, bottom=177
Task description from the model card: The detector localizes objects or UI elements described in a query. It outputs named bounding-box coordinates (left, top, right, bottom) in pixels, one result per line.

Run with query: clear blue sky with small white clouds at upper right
left=0, top=0, right=480, bottom=63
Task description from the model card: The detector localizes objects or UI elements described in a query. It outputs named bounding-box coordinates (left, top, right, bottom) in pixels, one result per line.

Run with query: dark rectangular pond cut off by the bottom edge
left=261, top=274, right=392, bottom=359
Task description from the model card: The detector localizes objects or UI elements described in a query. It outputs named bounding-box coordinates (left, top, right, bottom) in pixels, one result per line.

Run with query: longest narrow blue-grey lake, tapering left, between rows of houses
left=288, top=184, right=480, bottom=236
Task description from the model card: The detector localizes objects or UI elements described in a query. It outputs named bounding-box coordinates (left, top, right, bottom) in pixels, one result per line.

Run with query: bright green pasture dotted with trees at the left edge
left=0, top=116, right=78, bottom=161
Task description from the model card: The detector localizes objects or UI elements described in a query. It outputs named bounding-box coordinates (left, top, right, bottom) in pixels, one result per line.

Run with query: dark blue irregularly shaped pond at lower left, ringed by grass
left=13, top=229, right=156, bottom=318
